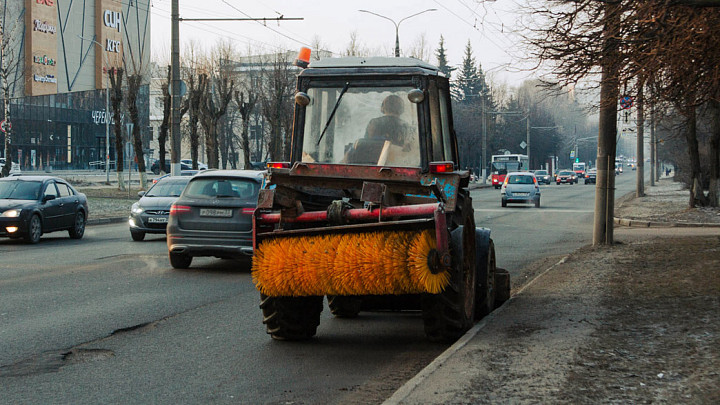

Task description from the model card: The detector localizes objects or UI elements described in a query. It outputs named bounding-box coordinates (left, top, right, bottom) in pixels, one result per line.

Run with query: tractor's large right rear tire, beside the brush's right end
left=422, top=226, right=476, bottom=342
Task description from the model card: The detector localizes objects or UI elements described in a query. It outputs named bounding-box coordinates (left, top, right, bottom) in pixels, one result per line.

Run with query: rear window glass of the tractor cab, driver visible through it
left=302, top=85, right=420, bottom=167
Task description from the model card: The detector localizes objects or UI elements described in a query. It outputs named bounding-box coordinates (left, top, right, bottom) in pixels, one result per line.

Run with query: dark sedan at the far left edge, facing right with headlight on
left=0, top=176, right=89, bottom=243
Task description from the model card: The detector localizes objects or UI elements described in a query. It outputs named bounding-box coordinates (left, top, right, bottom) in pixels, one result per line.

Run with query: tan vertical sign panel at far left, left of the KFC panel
left=24, top=0, right=58, bottom=96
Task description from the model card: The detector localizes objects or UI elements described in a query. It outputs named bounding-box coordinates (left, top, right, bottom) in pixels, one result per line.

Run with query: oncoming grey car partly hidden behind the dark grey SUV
left=128, top=176, right=190, bottom=241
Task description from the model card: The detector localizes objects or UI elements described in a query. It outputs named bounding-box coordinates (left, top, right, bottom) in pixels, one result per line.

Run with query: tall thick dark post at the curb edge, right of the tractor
left=593, top=2, right=620, bottom=245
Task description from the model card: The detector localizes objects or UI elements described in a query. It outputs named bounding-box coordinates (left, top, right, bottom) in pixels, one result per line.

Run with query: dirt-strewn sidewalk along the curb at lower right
left=386, top=180, right=720, bottom=404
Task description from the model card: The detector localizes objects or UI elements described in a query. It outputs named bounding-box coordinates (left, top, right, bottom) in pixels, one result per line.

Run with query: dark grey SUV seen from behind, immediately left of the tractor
left=167, top=170, right=265, bottom=269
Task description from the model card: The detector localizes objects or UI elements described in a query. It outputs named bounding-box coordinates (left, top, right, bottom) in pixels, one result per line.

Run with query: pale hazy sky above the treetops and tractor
left=151, top=0, right=528, bottom=85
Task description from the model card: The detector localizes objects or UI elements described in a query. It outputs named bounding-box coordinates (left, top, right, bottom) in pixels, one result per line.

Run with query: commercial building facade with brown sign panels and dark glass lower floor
left=0, top=0, right=151, bottom=170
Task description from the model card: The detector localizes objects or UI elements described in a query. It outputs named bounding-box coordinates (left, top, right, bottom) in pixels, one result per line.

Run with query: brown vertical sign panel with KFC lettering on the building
left=95, top=0, right=123, bottom=89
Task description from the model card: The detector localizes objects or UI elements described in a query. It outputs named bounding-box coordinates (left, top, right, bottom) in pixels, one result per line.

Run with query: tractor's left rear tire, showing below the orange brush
left=260, top=294, right=323, bottom=340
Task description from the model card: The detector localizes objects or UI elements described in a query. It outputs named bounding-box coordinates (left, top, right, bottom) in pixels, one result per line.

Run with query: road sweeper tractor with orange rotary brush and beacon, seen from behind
left=252, top=52, right=509, bottom=341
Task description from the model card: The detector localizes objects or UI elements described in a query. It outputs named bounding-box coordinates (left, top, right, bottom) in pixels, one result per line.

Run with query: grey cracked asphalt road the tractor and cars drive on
left=0, top=172, right=635, bottom=404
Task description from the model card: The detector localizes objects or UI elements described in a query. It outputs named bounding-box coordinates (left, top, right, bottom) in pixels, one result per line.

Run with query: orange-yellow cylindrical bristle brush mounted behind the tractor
left=252, top=230, right=450, bottom=297
